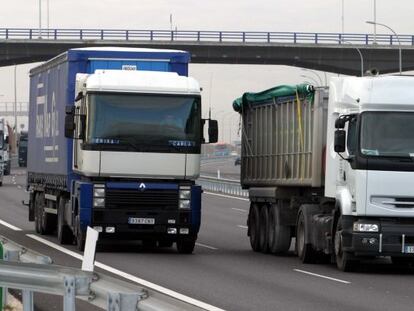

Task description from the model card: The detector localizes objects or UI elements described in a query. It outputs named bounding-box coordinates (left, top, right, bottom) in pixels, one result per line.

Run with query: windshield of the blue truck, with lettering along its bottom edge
left=87, top=93, right=201, bottom=153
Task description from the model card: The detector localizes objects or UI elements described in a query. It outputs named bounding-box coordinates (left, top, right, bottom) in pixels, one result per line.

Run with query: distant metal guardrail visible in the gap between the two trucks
left=197, top=175, right=249, bottom=197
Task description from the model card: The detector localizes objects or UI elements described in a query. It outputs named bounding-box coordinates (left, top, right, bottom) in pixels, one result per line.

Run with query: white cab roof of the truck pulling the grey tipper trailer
left=329, top=76, right=414, bottom=112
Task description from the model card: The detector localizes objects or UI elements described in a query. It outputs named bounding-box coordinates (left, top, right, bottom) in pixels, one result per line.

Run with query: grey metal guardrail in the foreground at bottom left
left=0, top=236, right=209, bottom=311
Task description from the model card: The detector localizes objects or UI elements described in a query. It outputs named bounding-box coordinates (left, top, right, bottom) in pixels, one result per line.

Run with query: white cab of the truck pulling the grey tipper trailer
left=325, top=76, right=414, bottom=268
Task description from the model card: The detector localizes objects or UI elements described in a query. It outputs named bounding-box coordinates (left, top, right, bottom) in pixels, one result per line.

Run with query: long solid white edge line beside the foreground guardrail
left=26, top=234, right=225, bottom=311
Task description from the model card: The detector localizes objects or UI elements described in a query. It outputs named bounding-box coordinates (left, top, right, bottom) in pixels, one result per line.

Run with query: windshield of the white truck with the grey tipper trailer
left=361, top=112, right=414, bottom=158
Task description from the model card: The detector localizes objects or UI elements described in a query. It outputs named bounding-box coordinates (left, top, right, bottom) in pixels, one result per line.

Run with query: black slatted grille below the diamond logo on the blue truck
left=105, top=189, right=178, bottom=210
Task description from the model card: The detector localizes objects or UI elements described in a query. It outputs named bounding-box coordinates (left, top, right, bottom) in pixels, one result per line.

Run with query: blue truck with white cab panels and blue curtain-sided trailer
left=27, top=48, right=218, bottom=253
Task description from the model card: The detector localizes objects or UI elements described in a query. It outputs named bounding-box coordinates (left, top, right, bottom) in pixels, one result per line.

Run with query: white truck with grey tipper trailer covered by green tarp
left=233, top=76, right=414, bottom=271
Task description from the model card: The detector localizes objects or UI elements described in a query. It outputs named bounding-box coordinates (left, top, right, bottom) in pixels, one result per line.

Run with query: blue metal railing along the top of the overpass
left=0, top=28, right=414, bottom=45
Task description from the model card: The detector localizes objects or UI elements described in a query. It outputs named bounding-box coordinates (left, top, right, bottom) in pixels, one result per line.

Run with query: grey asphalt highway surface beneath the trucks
left=0, top=170, right=414, bottom=311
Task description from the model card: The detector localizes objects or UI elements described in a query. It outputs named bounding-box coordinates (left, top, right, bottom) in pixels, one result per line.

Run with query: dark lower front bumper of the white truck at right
left=342, top=216, right=414, bottom=258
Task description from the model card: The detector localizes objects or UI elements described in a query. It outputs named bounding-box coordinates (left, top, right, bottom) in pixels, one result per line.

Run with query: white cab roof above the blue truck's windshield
left=86, top=70, right=200, bottom=95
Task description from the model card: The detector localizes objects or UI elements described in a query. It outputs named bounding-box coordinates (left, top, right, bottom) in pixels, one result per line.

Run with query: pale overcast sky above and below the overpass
left=0, top=0, right=414, bottom=141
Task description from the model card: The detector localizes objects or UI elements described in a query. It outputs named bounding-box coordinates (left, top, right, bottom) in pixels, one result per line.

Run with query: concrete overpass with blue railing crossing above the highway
left=0, top=28, right=414, bottom=75
